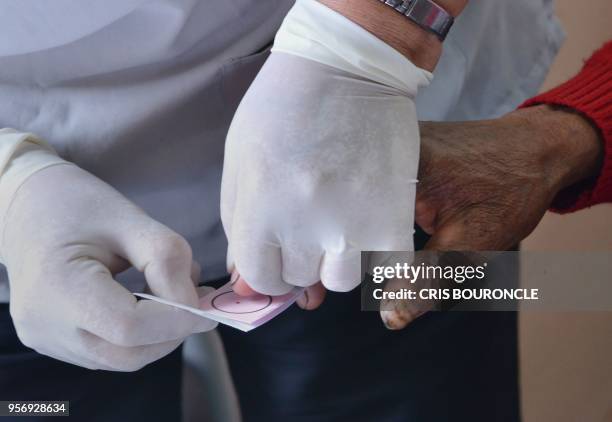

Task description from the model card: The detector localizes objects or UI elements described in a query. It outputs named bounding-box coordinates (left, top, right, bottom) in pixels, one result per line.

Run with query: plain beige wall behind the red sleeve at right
left=520, top=0, right=612, bottom=422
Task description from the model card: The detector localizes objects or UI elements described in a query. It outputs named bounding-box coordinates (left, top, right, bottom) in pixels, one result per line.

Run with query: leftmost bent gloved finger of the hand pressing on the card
left=232, top=237, right=293, bottom=296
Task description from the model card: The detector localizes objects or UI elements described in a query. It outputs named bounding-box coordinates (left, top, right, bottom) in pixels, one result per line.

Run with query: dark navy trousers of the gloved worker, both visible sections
left=0, top=231, right=520, bottom=422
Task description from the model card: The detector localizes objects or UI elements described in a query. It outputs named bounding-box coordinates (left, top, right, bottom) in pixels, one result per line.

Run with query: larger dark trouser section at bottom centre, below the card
left=220, top=298, right=520, bottom=422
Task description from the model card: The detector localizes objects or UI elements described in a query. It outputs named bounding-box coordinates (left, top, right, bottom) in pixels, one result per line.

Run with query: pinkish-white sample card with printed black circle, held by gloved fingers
left=134, top=283, right=304, bottom=332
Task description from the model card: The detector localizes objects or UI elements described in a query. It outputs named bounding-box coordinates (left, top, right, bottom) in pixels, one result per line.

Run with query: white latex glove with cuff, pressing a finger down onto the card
left=221, top=0, right=431, bottom=294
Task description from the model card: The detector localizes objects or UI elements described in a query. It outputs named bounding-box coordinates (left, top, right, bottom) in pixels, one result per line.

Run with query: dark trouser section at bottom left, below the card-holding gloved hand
left=0, top=304, right=182, bottom=422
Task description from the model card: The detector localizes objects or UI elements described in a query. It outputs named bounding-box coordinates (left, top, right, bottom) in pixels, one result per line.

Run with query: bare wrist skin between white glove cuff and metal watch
left=318, top=0, right=467, bottom=71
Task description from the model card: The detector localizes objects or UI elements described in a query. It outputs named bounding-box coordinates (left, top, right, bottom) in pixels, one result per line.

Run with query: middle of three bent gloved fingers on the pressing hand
left=281, top=245, right=323, bottom=287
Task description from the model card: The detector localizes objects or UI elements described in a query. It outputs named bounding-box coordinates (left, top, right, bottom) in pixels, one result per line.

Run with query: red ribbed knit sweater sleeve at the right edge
left=521, top=42, right=612, bottom=213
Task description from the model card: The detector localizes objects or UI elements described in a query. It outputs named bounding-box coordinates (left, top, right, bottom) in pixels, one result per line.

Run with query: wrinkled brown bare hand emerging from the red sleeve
left=381, top=106, right=602, bottom=329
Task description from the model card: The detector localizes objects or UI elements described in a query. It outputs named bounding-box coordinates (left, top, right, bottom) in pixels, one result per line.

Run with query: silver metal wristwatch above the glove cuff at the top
left=379, top=0, right=455, bottom=41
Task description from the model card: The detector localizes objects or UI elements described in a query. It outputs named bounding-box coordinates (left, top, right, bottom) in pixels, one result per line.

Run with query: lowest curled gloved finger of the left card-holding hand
left=79, top=330, right=183, bottom=372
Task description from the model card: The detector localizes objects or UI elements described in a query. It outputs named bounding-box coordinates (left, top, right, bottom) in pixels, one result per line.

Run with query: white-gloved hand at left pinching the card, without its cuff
left=0, top=158, right=216, bottom=371
